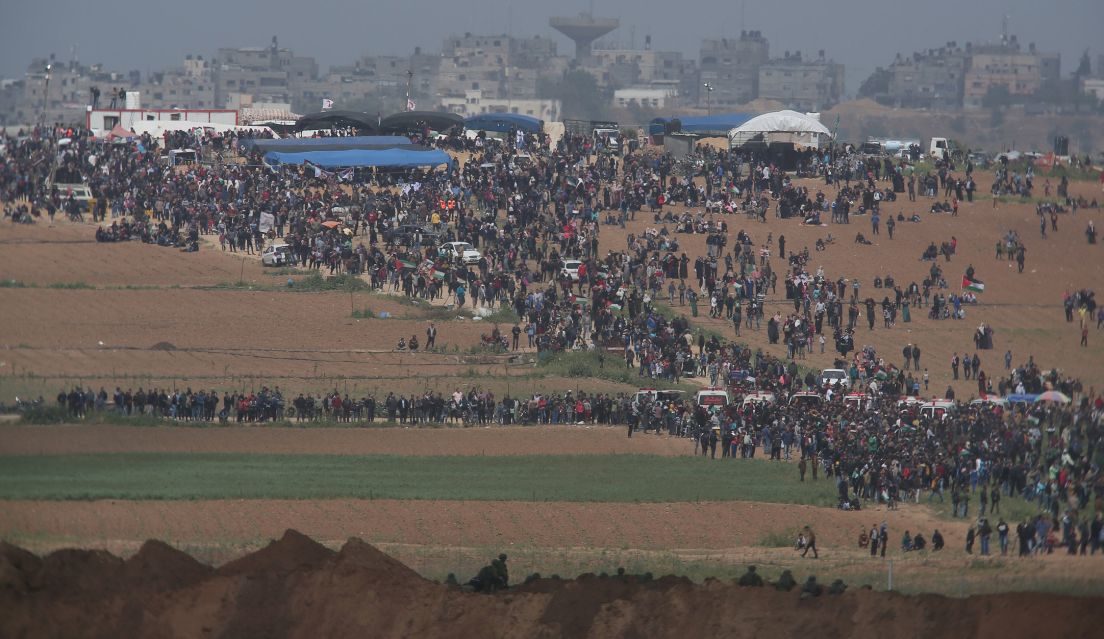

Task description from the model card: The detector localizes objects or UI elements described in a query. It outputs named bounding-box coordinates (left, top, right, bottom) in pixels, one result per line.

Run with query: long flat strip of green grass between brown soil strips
left=0, top=454, right=835, bottom=505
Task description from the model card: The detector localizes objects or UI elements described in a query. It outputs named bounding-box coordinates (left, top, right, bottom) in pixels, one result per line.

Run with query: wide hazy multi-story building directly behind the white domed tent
left=758, top=51, right=843, bottom=111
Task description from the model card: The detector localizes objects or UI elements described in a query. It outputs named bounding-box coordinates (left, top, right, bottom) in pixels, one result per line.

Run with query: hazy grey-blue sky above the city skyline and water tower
left=0, top=0, right=1104, bottom=94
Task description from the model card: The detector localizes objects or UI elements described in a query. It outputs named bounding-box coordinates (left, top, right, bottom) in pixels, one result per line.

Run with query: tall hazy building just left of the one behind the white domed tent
left=697, top=31, right=771, bottom=110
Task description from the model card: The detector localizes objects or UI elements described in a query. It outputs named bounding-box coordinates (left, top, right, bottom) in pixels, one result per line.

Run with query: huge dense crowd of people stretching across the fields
left=0, top=121, right=1104, bottom=560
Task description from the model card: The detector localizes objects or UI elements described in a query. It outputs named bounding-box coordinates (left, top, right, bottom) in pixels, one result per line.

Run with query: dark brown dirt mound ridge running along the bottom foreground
left=0, top=531, right=1104, bottom=638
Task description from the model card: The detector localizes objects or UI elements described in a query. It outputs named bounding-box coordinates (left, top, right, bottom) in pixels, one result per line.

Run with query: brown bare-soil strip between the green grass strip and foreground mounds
left=0, top=496, right=965, bottom=554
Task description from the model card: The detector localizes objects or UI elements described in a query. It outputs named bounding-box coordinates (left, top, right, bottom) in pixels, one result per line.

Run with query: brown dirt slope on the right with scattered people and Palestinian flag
left=602, top=173, right=1104, bottom=390
